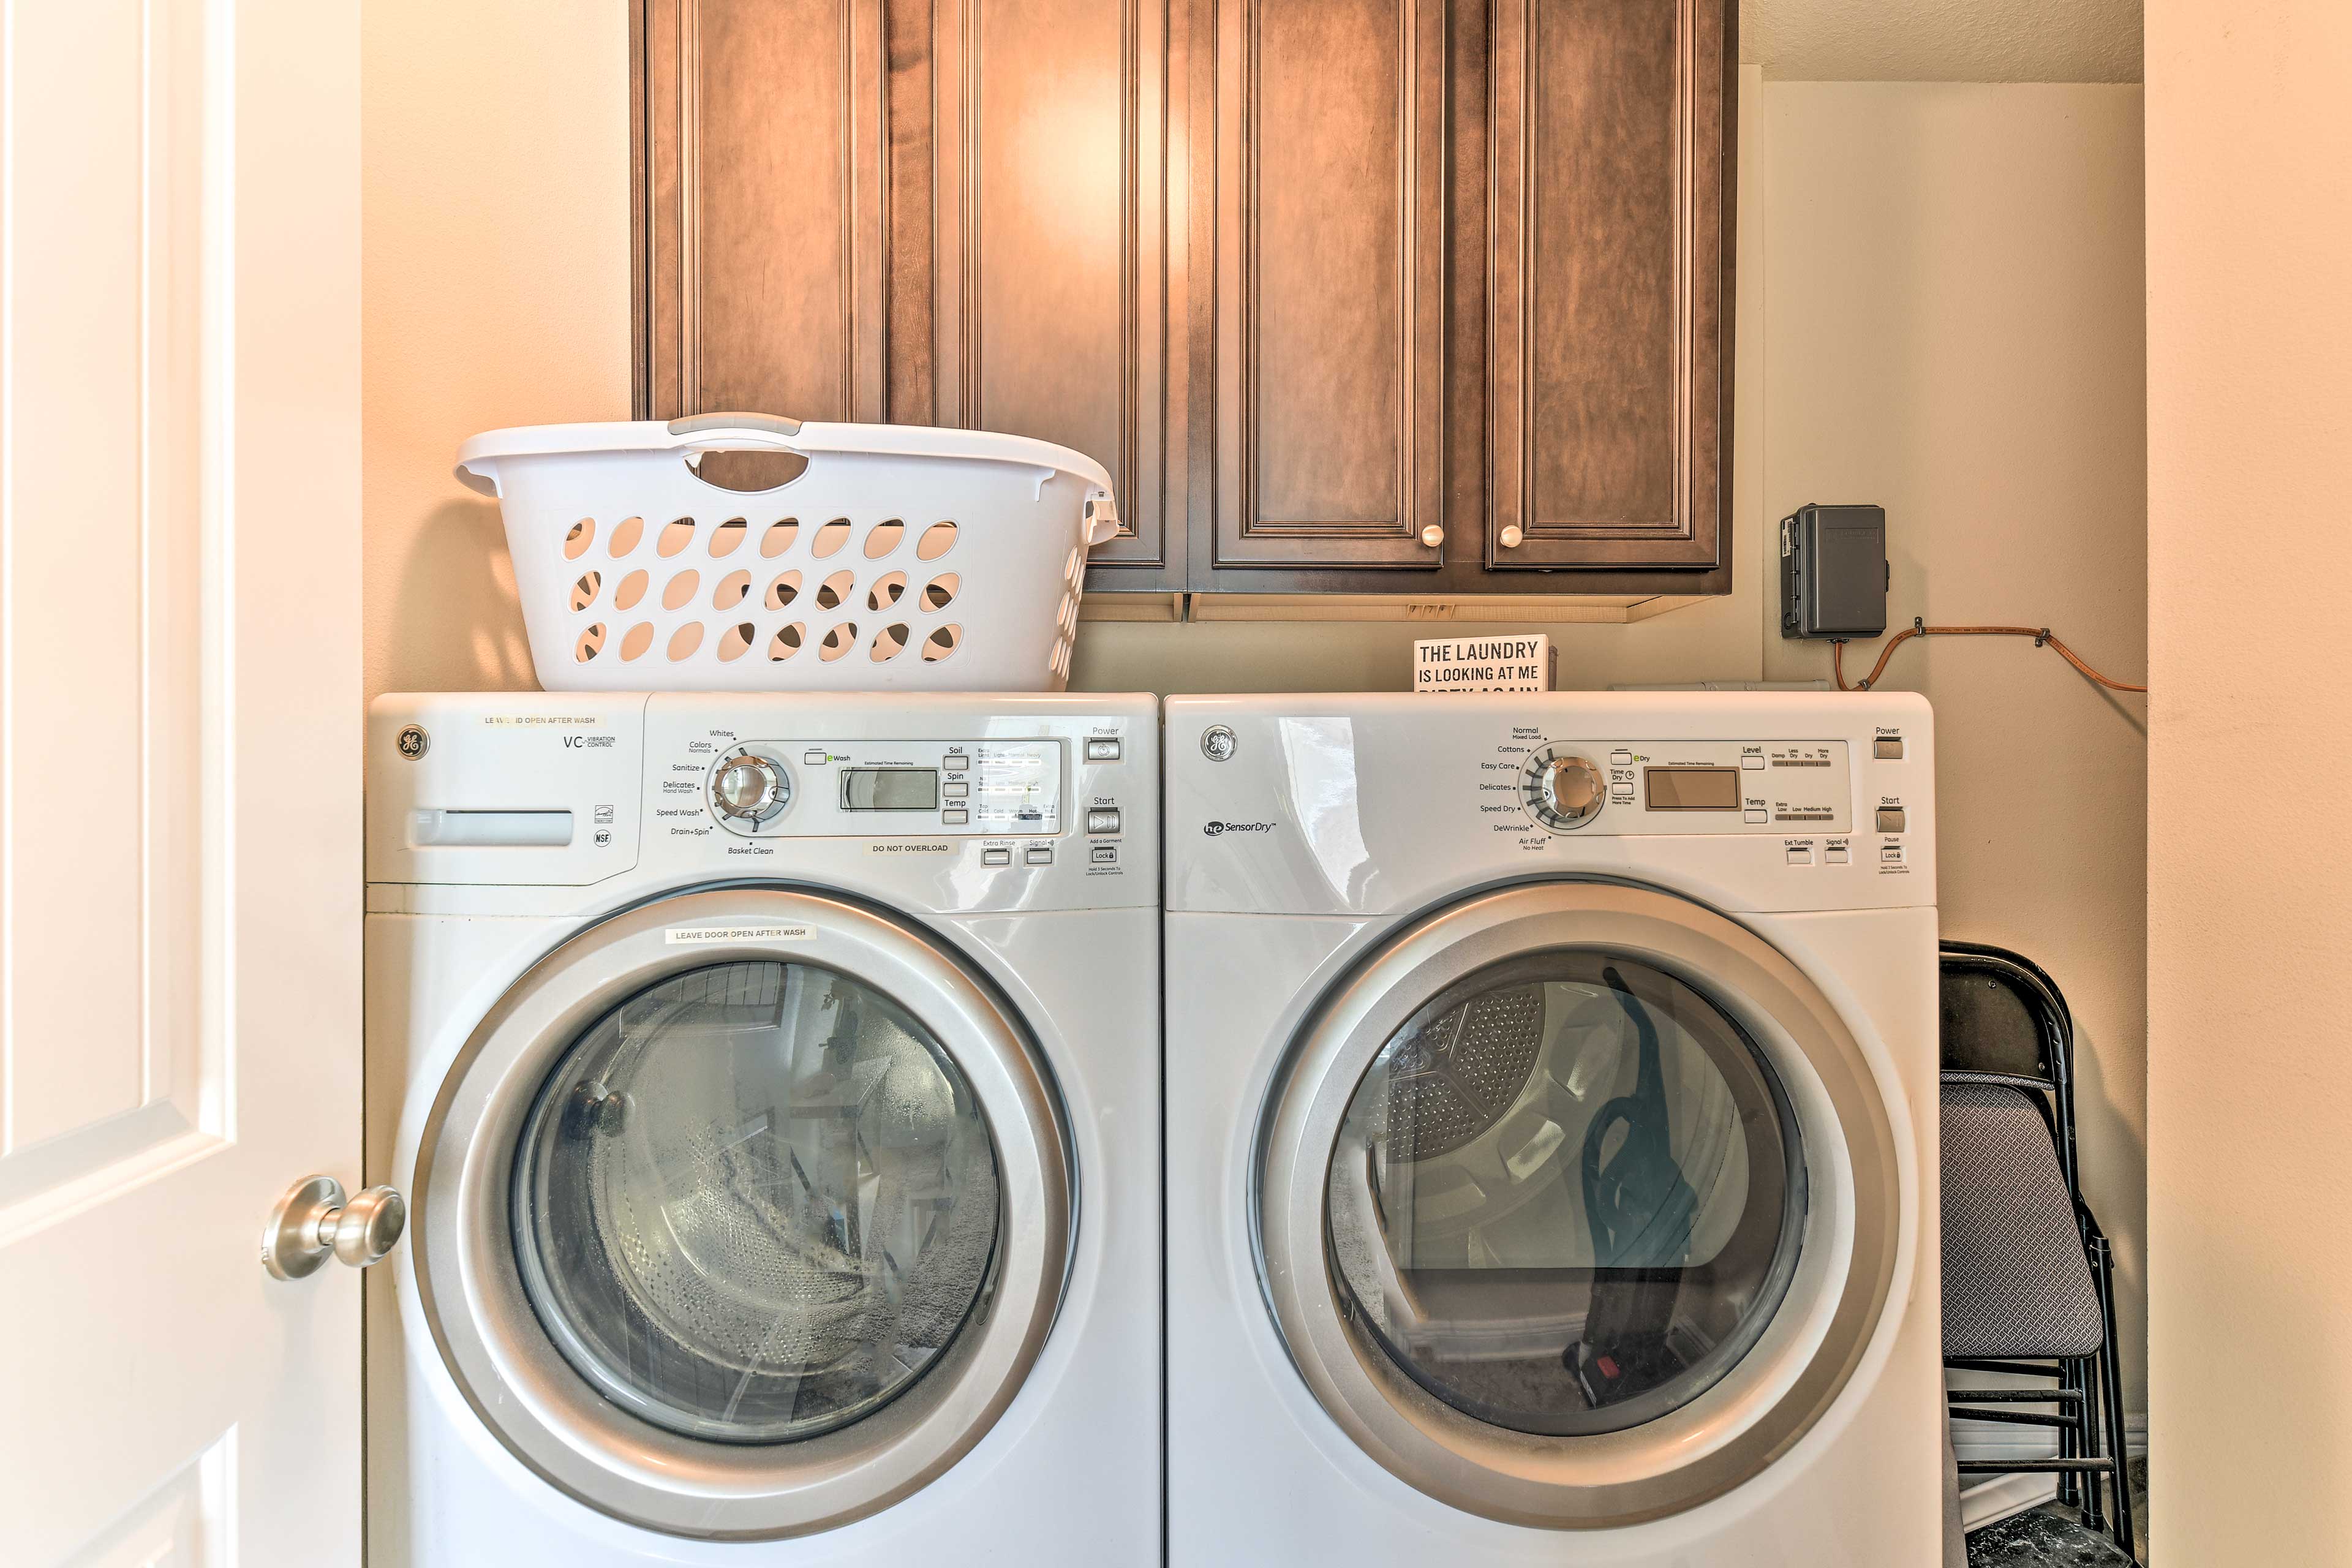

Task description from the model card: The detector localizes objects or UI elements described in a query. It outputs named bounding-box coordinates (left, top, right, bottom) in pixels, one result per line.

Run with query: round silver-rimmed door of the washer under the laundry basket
left=414, top=889, right=1072, bottom=1540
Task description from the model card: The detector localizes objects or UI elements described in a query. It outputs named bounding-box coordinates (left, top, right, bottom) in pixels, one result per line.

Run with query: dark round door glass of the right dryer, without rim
left=1324, top=950, right=1804, bottom=1436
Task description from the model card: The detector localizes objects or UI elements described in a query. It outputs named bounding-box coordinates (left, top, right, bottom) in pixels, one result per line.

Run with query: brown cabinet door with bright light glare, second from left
left=933, top=0, right=1183, bottom=573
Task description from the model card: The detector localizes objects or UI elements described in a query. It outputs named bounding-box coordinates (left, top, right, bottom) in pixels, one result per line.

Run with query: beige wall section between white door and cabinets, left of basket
left=360, top=0, right=630, bottom=696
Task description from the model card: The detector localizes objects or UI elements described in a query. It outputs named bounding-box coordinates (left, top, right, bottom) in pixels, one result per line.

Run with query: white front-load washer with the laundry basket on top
left=367, top=693, right=1159, bottom=1568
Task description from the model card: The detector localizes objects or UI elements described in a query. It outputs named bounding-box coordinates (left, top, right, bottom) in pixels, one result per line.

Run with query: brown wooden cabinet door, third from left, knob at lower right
left=1213, top=0, right=1447, bottom=567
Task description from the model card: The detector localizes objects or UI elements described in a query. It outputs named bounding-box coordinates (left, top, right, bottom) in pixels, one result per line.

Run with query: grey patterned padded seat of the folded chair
left=1943, top=1079, right=2105, bottom=1359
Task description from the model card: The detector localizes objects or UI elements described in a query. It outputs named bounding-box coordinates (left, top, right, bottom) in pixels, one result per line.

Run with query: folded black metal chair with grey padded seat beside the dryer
left=1940, top=943, right=2136, bottom=1561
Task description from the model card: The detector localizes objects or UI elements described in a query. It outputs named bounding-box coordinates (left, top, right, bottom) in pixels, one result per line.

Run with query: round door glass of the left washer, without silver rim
left=513, top=962, right=1000, bottom=1444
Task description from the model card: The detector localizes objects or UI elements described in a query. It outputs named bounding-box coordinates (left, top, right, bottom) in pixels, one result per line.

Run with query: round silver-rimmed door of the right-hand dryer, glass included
left=1256, top=884, right=1907, bottom=1528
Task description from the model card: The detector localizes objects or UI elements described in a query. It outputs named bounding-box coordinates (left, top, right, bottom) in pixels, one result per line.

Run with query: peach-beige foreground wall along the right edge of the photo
left=2147, top=0, right=2352, bottom=1568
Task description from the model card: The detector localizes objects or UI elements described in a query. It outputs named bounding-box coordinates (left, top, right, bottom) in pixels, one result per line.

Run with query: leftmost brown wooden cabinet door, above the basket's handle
left=639, top=0, right=889, bottom=418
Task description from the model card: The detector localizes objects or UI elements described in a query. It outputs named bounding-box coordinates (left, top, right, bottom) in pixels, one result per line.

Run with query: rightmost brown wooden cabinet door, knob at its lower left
left=1487, top=0, right=1731, bottom=567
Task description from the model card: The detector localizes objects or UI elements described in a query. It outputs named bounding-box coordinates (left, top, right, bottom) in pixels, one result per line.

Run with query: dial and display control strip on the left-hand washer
left=701, top=741, right=1063, bottom=839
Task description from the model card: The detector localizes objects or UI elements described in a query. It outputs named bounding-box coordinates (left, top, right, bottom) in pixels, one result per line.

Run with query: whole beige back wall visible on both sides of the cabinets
left=362, top=15, right=2145, bottom=1408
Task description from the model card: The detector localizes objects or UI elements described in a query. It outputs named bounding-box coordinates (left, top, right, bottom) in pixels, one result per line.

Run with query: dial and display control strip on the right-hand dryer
left=1520, top=741, right=1844, bottom=835
